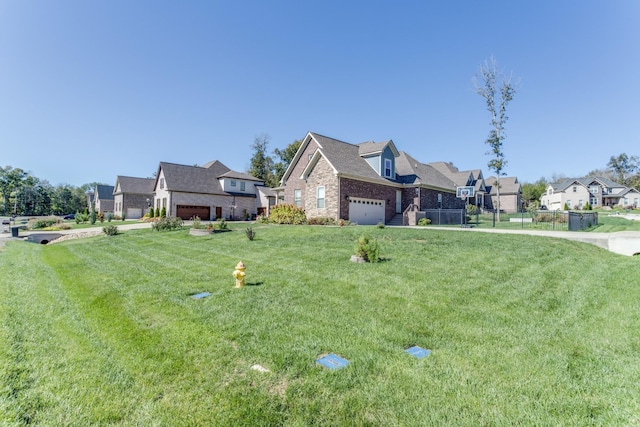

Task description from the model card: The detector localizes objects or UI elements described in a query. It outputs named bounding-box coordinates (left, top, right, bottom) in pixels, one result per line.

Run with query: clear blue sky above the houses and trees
left=0, top=0, right=640, bottom=186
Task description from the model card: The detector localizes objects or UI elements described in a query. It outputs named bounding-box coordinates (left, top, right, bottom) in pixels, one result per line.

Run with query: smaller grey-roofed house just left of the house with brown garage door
left=113, top=175, right=156, bottom=219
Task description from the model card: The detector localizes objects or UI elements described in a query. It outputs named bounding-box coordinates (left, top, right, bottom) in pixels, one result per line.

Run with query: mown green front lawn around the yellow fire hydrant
left=0, top=224, right=640, bottom=426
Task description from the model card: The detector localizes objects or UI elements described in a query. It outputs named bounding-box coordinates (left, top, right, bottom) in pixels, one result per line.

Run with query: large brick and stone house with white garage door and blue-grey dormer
left=275, top=132, right=463, bottom=224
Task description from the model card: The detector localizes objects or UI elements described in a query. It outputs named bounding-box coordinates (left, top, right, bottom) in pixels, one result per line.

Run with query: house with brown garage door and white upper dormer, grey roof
left=153, top=160, right=264, bottom=220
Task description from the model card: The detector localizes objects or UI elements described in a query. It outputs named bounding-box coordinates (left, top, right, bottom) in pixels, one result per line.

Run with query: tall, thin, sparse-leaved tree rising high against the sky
left=474, top=57, right=516, bottom=221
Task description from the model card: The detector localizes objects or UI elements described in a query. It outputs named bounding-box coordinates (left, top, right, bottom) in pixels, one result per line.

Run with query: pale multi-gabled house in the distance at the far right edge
left=540, top=176, right=640, bottom=210
